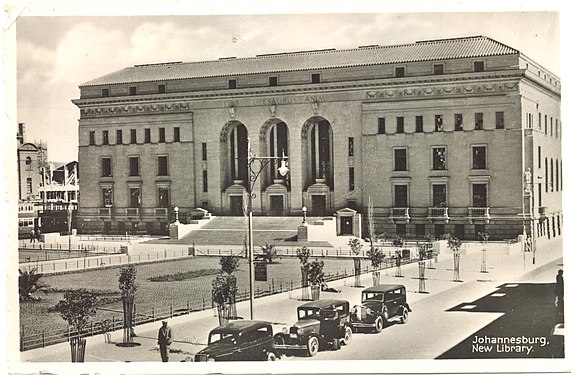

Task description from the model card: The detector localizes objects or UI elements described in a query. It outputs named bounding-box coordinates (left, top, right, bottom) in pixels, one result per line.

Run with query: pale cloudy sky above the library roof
left=12, top=8, right=560, bottom=161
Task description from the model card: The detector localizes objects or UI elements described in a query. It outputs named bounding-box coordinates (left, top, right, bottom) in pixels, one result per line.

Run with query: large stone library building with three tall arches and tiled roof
left=73, top=36, right=562, bottom=238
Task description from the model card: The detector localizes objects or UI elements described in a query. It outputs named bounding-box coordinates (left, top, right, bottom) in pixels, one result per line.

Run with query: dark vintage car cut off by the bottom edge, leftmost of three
left=194, top=320, right=277, bottom=362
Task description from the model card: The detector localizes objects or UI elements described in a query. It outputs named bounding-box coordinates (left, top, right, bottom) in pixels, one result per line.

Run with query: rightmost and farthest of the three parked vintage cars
left=351, top=284, right=412, bottom=332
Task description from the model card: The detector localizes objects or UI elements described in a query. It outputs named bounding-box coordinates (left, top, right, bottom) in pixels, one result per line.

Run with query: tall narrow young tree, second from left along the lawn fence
left=117, top=264, right=138, bottom=347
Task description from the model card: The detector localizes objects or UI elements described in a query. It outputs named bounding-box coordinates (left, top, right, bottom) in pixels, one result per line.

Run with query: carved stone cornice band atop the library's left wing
left=80, top=102, right=190, bottom=118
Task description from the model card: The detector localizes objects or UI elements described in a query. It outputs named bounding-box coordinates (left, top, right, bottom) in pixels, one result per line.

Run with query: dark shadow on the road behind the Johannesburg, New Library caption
left=437, top=283, right=564, bottom=359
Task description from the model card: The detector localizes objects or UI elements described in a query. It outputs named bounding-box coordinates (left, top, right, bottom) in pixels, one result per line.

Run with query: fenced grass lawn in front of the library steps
left=20, top=257, right=370, bottom=340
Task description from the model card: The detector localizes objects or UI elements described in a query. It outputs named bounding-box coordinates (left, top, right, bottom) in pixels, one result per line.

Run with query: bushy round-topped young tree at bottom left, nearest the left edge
left=55, top=289, right=97, bottom=362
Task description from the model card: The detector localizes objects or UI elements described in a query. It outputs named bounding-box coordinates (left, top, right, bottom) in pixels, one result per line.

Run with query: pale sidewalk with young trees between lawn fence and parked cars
left=20, top=237, right=563, bottom=362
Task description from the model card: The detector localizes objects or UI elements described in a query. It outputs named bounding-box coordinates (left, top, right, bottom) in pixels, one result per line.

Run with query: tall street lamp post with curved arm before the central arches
left=247, top=137, right=289, bottom=320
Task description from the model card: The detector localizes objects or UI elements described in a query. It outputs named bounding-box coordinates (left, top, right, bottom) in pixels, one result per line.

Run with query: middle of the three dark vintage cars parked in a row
left=274, top=299, right=353, bottom=357
